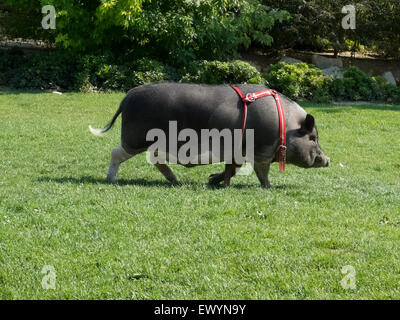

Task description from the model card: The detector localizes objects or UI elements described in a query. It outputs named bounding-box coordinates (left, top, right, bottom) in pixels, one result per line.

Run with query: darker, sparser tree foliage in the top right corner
left=263, top=0, right=400, bottom=57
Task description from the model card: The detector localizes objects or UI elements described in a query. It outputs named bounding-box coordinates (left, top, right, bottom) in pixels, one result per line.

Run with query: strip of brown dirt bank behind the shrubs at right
left=242, top=49, right=400, bottom=82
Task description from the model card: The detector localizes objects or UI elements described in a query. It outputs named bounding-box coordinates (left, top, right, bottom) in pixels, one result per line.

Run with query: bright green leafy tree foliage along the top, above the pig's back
left=0, top=0, right=289, bottom=64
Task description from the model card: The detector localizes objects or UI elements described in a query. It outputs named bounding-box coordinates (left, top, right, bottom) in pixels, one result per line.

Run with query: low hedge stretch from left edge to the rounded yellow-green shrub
left=0, top=51, right=264, bottom=91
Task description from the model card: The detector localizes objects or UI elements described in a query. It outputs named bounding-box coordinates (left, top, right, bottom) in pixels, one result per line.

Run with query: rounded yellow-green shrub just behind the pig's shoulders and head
left=265, top=62, right=332, bottom=102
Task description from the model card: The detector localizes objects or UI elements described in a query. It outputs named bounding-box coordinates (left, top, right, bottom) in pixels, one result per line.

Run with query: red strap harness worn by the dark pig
left=232, top=86, right=286, bottom=171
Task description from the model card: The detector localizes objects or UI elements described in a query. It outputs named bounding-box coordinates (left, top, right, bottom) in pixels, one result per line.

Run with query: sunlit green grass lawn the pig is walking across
left=0, top=91, right=400, bottom=299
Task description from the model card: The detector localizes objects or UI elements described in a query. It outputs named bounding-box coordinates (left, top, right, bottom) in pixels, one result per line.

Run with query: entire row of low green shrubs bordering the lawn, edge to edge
left=0, top=50, right=400, bottom=103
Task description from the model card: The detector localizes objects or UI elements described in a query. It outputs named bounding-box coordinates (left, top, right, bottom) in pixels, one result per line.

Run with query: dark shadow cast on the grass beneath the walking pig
left=37, top=176, right=291, bottom=190
